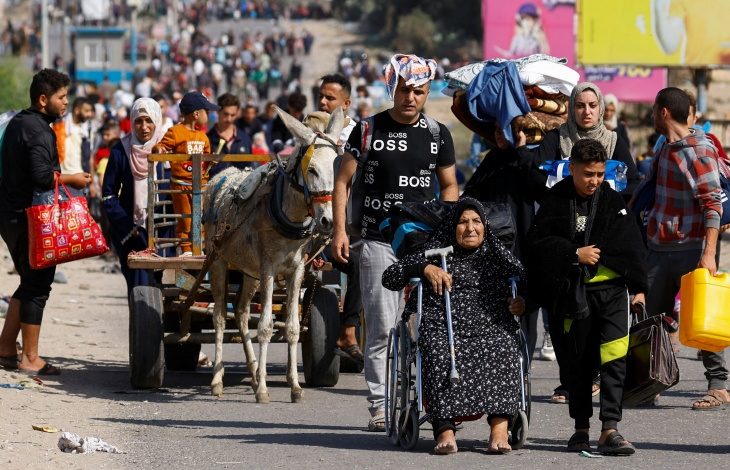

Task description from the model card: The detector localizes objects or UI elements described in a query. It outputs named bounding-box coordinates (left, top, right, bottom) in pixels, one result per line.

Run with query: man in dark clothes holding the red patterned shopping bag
left=0, top=69, right=91, bottom=375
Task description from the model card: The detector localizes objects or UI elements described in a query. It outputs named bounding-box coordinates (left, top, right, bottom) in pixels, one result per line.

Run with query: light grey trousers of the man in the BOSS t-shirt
left=360, top=240, right=401, bottom=416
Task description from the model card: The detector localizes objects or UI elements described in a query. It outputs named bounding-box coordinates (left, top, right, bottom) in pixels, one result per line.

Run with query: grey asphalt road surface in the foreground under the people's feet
left=94, top=336, right=730, bottom=469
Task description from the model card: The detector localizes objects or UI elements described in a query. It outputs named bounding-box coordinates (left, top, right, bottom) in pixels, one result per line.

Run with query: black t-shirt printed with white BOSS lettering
left=345, top=111, right=455, bottom=241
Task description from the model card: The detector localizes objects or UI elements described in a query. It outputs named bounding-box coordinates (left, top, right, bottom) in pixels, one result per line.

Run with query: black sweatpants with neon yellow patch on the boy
left=562, top=283, right=630, bottom=429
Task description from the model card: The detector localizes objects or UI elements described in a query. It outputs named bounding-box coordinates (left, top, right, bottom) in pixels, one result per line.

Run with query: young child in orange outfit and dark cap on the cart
left=155, top=91, right=220, bottom=256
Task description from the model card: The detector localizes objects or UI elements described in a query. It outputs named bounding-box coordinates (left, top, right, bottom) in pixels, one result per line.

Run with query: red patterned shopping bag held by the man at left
left=25, top=176, right=109, bottom=269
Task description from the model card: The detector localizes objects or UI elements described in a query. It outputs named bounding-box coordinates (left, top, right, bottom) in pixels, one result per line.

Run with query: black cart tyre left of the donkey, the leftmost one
left=129, top=286, right=165, bottom=388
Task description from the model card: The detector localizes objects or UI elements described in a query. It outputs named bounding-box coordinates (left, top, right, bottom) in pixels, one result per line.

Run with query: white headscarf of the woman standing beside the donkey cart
left=122, top=98, right=165, bottom=226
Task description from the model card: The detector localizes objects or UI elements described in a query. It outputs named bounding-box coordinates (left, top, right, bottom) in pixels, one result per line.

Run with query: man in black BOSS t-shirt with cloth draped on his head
left=332, top=54, right=459, bottom=431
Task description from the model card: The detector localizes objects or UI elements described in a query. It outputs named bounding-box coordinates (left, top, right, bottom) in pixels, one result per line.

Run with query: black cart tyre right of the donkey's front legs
left=302, top=288, right=340, bottom=387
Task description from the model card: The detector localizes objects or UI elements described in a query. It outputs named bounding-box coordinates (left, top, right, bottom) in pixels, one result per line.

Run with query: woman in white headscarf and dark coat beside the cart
left=102, top=98, right=165, bottom=293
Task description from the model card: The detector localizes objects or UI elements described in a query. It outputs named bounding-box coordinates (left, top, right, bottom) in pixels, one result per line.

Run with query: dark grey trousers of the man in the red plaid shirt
left=646, top=248, right=728, bottom=390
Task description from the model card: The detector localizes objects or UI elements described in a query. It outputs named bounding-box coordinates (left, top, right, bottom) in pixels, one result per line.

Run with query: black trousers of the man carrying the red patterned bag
left=0, top=212, right=56, bottom=325
